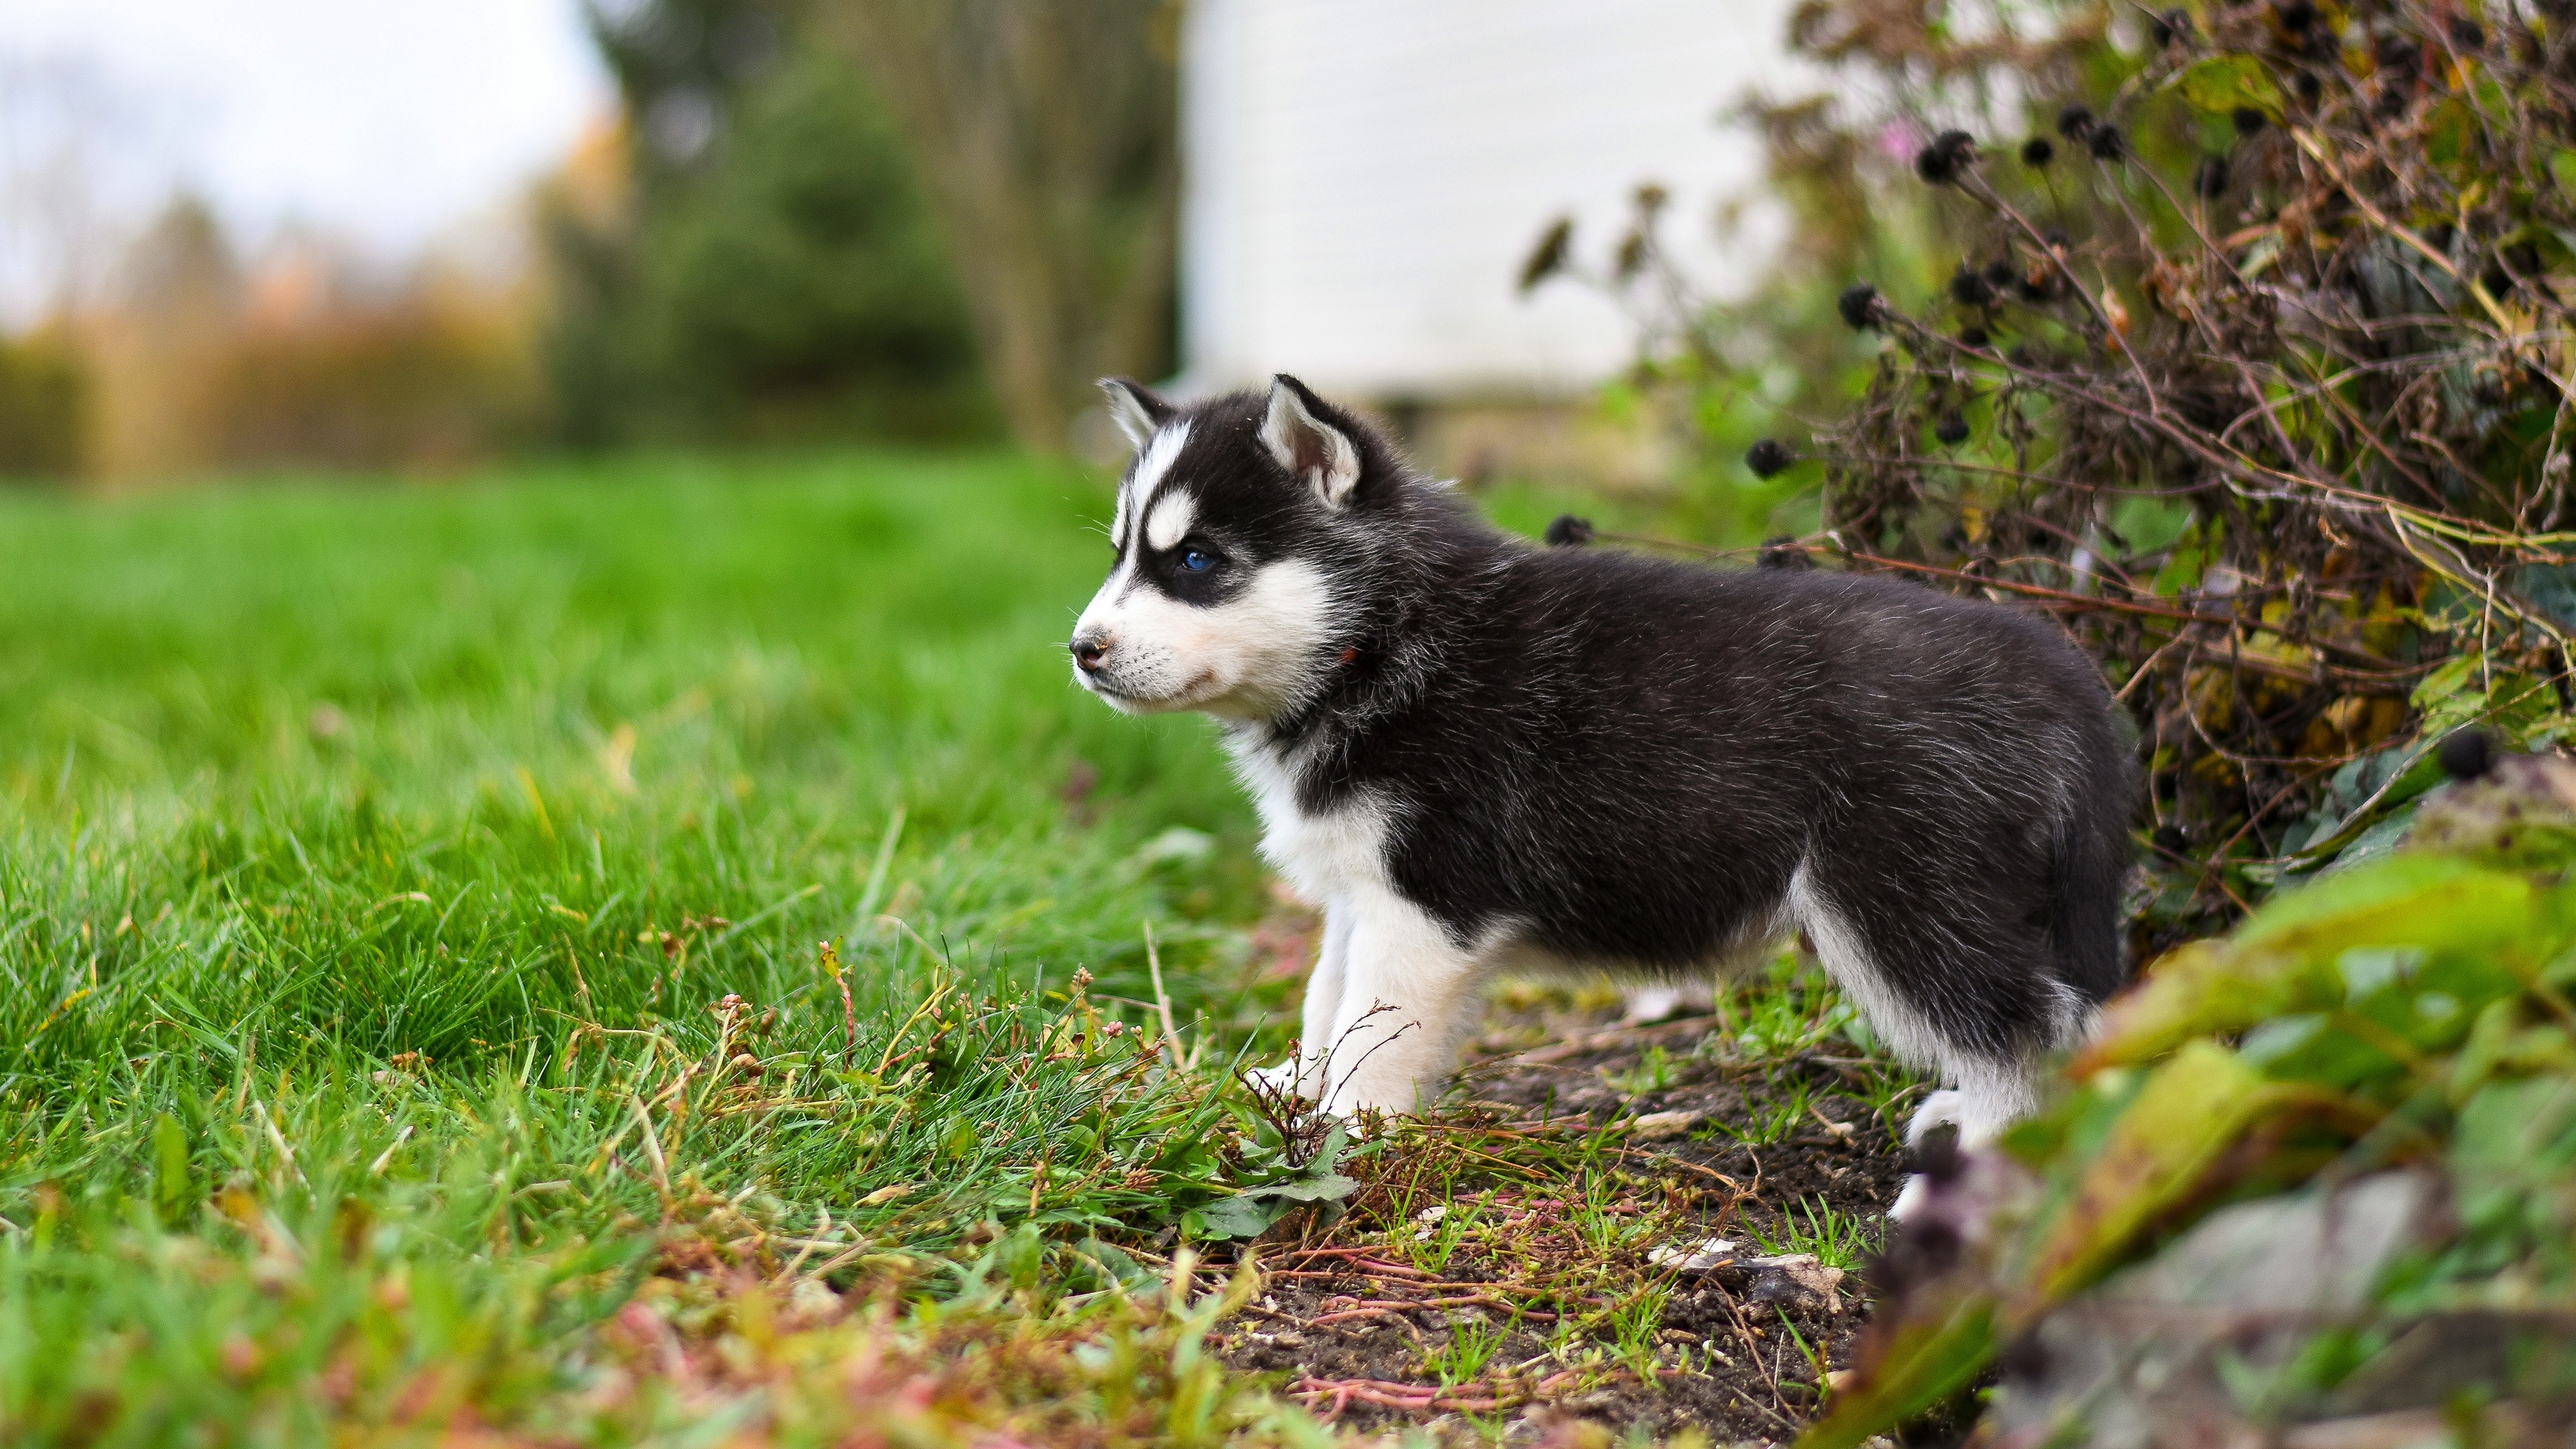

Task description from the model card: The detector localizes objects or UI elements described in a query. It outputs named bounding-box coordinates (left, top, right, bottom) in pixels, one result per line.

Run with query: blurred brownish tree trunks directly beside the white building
left=812, top=0, right=1180, bottom=449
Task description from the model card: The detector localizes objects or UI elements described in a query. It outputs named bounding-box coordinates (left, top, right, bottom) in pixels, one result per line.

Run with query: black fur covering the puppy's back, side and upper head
left=1081, top=382, right=2138, bottom=1077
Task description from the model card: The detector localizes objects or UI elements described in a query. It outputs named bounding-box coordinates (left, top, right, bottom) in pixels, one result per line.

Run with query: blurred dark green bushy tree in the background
left=543, top=0, right=991, bottom=446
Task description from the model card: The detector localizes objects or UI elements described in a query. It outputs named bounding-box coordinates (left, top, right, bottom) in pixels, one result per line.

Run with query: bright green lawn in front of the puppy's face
left=0, top=456, right=1329, bottom=1444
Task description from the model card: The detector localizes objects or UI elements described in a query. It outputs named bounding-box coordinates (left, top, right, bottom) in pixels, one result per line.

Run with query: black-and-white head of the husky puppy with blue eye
left=1071, top=376, right=1401, bottom=719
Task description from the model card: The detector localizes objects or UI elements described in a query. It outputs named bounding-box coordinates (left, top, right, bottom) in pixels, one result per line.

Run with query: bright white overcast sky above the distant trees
left=0, top=0, right=610, bottom=265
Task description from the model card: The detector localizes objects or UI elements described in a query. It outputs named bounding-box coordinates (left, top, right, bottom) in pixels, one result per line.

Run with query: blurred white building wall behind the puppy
left=1183, top=0, right=1795, bottom=397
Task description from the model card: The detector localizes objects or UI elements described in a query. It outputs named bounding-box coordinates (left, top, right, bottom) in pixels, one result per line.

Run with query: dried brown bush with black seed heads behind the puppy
left=1558, top=0, right=2576, bottom=949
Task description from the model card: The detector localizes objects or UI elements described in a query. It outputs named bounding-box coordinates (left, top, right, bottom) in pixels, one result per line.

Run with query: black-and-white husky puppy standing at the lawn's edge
left=1071, top=376, right=2138, bottom=1144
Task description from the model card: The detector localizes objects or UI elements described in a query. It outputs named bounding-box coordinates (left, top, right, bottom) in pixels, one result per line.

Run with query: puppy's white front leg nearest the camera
left=1324, top=892, right=1484, bottom=1116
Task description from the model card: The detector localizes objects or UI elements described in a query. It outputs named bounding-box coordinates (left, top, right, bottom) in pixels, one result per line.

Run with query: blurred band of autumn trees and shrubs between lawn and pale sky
left=0, top=0, right=1177, bottom=485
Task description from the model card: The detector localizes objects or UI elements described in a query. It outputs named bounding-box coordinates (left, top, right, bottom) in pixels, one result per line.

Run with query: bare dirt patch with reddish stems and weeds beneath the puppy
left=1218, top=1008, right=1904, bottom=1444
